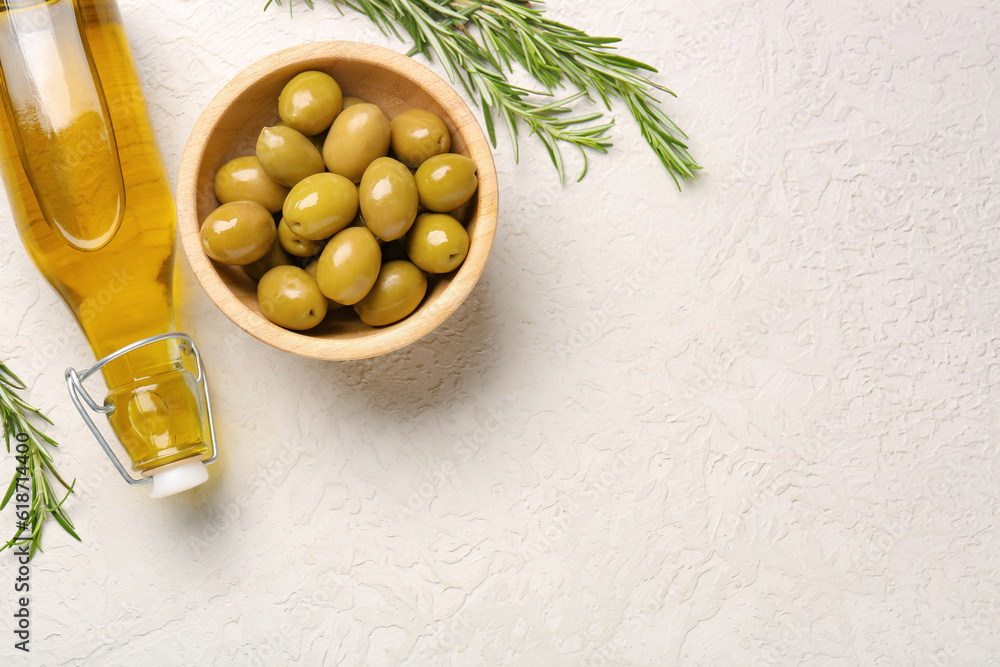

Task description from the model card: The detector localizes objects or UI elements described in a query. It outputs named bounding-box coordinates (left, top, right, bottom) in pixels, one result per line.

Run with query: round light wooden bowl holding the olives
left=177, top=42, right=497, bottom=360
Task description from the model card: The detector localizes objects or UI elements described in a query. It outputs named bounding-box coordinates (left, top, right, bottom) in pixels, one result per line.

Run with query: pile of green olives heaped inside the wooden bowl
left=201, top=71, right=478, bottom=330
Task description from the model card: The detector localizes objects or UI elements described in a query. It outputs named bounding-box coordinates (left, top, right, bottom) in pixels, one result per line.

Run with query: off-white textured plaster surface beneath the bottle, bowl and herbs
left=0, top=0, right=1000, bottom=666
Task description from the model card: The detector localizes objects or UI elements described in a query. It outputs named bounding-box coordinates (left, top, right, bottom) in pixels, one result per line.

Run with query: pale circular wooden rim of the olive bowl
left=176, top=40, right=499, bottom=361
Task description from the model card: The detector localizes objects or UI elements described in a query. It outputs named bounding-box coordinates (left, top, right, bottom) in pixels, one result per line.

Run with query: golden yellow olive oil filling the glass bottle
left=0, top=0, right=207, bottom=472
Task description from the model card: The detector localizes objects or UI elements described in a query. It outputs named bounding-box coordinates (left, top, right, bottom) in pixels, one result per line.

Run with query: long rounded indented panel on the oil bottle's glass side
left=0, top=0, right=125, bottom=252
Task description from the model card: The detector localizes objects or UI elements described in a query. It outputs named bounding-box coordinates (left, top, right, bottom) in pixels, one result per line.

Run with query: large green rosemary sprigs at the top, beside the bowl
left=265, top=0, right=700, bottom=187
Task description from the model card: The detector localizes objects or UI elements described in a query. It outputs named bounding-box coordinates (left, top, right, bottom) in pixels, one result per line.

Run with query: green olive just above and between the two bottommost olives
left=316, top=227, right=382, bottom=306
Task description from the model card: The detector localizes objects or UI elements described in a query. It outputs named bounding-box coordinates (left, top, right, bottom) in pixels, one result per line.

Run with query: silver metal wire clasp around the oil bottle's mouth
left=66, top=333, right=219, bottom=486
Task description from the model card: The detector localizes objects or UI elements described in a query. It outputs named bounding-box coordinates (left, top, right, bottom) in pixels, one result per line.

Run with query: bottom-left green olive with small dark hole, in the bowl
left=257, top=266, right=327, bottom=331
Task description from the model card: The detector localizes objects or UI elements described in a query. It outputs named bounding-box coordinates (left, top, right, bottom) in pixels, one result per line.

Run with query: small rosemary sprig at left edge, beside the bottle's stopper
left=0, top=362, right=80, bottom=560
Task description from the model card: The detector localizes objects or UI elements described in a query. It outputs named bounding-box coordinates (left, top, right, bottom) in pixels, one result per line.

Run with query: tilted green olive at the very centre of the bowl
left=282, top=172, right=358, bottom=241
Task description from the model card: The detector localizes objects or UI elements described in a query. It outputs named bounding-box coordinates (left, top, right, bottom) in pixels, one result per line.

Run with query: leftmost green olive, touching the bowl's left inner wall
left=201, top=201, right=277, bottom=266
